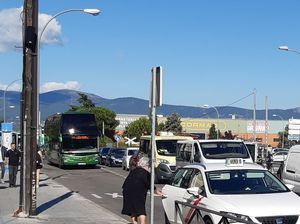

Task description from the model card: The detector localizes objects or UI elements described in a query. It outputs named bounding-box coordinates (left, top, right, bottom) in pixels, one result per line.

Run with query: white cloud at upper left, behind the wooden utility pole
left=0, top=7, right=61, bottom=53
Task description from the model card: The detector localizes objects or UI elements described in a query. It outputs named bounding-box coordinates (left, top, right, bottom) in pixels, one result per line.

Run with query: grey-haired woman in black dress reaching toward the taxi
left=122, top=157, right=162, bottom=224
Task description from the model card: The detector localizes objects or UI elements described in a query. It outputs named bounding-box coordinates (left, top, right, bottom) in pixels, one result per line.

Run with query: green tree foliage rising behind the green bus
left=70, top=93, right=119, bottom=138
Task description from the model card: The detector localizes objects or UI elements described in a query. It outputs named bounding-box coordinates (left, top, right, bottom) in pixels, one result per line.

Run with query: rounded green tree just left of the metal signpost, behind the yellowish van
left=124, top=117, right=151, bottom=141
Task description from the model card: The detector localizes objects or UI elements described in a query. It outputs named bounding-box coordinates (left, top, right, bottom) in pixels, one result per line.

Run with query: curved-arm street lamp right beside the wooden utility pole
left=37, top=9, right=100, bottom=136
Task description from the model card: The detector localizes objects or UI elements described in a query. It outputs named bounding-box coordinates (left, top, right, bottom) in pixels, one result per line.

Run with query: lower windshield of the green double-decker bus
left=62, top=137, right=97, bottom=151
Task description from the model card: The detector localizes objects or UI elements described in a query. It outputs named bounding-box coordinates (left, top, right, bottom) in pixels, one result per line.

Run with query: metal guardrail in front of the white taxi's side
left=175, top=201, right=258, bottom=224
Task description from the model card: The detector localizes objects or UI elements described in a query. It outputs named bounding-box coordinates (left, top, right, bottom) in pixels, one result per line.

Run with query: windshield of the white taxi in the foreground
left=206, top=169, right=289, bottom=195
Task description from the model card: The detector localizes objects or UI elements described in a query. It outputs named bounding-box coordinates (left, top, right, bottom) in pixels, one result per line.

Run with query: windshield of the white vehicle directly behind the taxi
left=200, top=142, right=249, bottom=159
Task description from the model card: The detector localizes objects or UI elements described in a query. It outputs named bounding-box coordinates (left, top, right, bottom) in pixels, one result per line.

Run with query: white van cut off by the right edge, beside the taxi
left=281, top=145, right=300, bottom=193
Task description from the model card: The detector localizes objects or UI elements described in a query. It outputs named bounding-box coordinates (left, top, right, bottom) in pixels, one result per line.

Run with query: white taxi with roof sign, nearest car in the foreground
left=162, top=158, right=300, bottom=224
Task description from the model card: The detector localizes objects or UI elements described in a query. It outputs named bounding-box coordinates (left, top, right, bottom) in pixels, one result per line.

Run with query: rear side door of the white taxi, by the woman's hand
left=162, top=168, right=194, bottom=222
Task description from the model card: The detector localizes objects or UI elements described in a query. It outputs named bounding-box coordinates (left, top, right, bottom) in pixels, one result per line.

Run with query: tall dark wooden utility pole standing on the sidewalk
left=20, top=0, right=38, bottom=217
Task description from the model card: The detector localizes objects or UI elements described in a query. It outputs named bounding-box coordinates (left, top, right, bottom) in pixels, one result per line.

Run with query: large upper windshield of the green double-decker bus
left=61, top=114, right=98, bottom=136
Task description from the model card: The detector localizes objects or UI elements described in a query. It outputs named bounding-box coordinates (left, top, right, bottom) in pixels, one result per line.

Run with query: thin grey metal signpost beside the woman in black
left=150, top=72, right=156, bottom=224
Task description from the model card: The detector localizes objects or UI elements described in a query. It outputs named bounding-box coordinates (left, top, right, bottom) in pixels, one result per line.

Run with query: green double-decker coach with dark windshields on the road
left=44, top=112, right=99, bottom=167
